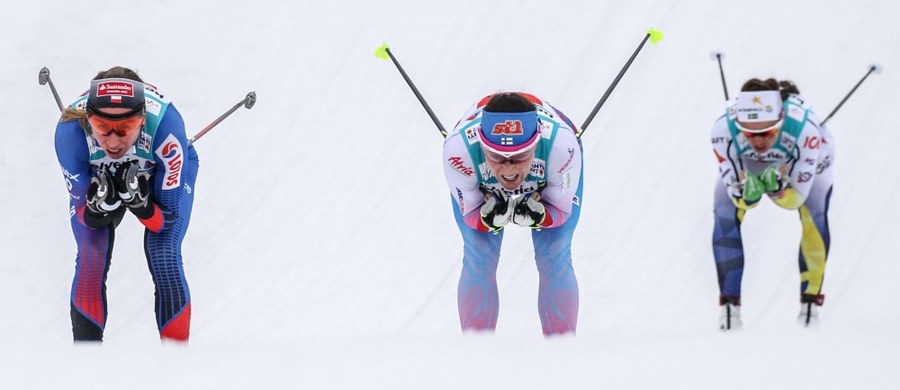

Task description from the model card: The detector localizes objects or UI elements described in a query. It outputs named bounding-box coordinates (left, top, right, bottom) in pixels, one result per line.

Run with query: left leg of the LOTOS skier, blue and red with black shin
left=69, top=210, right=125, bottom=341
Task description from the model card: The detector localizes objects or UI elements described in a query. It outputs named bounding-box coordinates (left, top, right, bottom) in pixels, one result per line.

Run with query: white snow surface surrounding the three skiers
left=0, top=0, right=900, bottom=389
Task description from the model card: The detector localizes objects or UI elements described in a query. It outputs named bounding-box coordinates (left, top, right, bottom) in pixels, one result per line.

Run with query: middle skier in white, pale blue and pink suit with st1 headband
left=443, top=93, right=583, bottom=335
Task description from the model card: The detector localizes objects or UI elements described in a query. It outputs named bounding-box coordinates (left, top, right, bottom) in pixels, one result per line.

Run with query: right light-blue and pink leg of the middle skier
left=531, top=172, right=584, bottom=335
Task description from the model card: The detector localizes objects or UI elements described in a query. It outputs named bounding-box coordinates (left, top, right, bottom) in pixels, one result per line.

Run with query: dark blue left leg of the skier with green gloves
left=712, top=182, right=744, bottom=304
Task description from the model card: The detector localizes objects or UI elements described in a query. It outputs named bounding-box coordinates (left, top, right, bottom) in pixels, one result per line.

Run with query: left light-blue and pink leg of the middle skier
left=451, top=197, right=503, bottom=331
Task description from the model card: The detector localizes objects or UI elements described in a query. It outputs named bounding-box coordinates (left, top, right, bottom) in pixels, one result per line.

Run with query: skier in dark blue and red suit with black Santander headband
left=56, top=67, right=199, bottom=341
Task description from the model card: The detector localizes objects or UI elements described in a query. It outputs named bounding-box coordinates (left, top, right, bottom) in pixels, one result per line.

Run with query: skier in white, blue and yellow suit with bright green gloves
left=712, top=78, right=835, bottom=330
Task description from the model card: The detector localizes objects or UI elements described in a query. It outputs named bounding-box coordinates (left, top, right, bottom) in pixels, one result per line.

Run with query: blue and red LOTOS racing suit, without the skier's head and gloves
left=56, top=85, right=199, bottom=341
